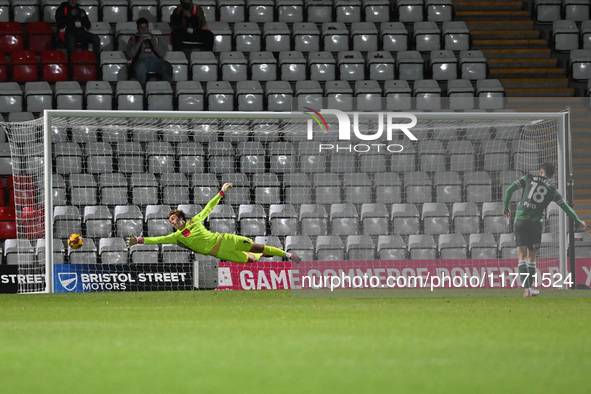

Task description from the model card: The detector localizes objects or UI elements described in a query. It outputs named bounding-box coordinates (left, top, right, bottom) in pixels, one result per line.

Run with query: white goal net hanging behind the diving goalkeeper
left=4, top=109, right=566, bottom=292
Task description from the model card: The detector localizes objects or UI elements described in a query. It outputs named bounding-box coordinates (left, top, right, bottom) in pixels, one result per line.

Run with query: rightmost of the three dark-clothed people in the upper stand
left=170, top=0, right=214, bottom=51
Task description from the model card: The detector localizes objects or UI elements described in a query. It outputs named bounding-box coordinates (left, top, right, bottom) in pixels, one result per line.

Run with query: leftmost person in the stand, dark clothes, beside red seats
left=55, top=0, right=101, bottom=63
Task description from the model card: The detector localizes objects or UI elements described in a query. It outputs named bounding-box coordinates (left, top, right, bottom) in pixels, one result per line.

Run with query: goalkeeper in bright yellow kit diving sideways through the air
left=125, top=182, right=301, bottom=263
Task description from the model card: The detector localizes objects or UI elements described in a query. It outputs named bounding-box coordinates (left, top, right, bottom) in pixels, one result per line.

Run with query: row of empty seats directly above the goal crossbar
left=0, top=80, right=505, bottom=113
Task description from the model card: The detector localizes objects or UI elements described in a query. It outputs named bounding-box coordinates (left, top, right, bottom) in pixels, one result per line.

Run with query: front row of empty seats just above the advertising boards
left=3, top=229, right=591, bottom=264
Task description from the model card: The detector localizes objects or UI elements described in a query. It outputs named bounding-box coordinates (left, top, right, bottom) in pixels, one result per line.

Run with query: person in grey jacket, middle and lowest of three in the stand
left=127, top=18, right=172, bottom=90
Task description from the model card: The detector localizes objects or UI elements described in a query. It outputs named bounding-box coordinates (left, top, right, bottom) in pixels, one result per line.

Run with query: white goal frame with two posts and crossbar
left=38, top=109, right=570, bottom=293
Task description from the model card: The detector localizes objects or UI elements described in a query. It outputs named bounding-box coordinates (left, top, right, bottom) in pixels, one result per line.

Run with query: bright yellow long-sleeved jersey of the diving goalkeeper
left=143, top=193, right=222, bottom=255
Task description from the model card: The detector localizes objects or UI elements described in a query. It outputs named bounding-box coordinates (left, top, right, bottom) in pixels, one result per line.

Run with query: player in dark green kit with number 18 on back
left=503, top=163, right=587, bottom=297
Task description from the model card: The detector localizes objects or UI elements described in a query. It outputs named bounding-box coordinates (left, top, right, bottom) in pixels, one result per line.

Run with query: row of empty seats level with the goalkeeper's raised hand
left=46, top=171, right=521, bottom=206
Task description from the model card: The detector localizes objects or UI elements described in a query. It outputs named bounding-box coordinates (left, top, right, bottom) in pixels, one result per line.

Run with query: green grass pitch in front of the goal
left=0, top=291, right=591, bottom=393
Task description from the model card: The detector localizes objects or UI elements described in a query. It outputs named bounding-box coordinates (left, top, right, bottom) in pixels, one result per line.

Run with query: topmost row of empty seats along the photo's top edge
left=0, top=0, right=453, bottom=23
